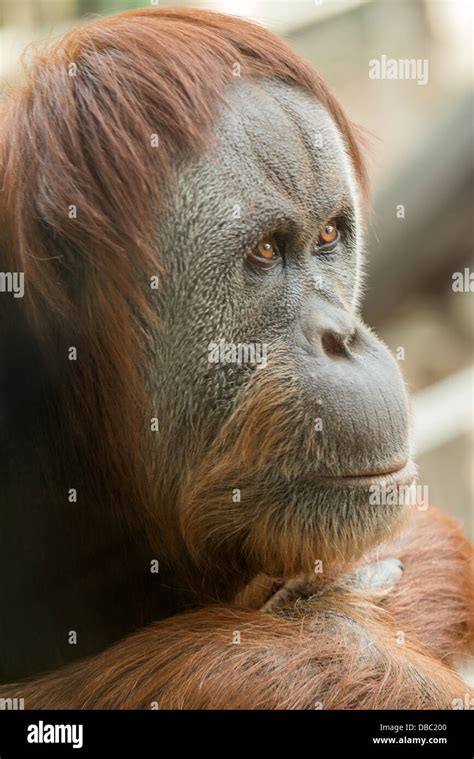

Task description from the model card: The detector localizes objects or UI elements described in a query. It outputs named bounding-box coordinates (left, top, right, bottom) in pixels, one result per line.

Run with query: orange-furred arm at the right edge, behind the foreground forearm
left=265, top=507, right=474, bottom=662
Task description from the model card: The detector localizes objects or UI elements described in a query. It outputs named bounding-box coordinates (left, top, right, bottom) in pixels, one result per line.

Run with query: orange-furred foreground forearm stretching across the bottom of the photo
left=8, top=595, right=468, bottom=709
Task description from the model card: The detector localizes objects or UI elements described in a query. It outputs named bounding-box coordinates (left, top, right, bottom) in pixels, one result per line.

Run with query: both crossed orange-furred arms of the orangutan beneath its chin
left=7, top=509, right=473, bottom=709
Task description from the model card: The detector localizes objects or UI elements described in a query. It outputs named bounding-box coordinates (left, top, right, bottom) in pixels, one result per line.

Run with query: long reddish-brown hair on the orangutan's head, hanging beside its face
left=0, top=9, right=367, bottom=516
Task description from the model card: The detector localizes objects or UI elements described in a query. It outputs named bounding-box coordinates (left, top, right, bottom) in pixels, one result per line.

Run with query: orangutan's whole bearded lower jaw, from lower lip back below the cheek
left=179, top=463, right=415, bottom=583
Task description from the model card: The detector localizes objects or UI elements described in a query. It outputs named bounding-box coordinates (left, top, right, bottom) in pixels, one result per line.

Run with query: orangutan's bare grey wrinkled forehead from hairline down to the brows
left=161, top=79, right=360, bottom=254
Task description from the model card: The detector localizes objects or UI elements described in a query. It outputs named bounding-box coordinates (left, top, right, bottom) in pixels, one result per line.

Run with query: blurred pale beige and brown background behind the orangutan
left=0, top=0, right=474, bottom=538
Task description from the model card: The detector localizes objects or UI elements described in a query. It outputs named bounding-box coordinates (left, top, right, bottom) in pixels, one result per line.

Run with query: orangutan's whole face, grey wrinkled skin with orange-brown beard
left=151, top=80, right=411, bottom=593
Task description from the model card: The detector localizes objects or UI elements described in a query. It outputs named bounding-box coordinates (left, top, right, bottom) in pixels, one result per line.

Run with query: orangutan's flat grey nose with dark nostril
left=302, top=306, right=355, bottom=357
